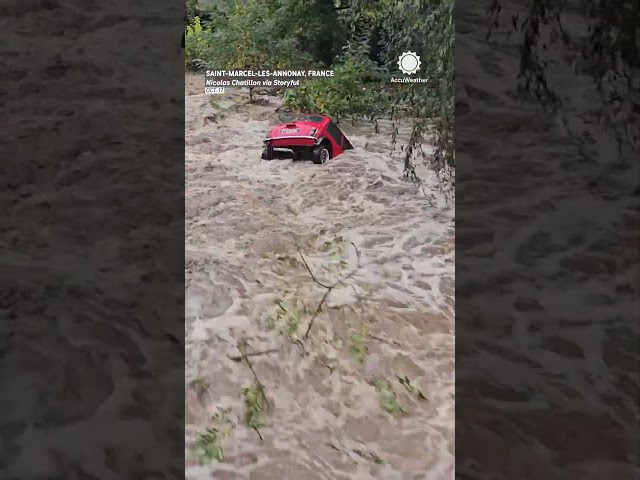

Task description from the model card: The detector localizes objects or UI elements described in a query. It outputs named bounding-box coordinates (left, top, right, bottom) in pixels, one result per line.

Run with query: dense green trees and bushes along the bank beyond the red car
left=185, top=0, right=455, bottom=185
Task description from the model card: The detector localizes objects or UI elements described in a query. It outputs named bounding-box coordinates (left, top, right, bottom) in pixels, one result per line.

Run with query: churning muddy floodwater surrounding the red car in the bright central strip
left=185, top=77, right=455, bottom=480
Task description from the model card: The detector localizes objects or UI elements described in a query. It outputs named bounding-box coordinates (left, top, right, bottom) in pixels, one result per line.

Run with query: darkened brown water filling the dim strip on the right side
left=455, top=0, right=640, bottom=480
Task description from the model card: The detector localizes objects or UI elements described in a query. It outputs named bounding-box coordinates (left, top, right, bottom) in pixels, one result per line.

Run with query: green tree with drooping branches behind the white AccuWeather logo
left=350, top=0, right=455, bottom=187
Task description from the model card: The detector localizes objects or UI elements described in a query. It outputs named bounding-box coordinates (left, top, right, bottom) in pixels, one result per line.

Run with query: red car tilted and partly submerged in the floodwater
left=262, top=114, right=353, bottom=164
